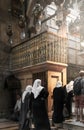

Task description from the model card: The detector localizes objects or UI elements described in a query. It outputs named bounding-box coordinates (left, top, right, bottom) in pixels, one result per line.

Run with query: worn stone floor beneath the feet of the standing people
left=0, top=118, right=84, bottom=130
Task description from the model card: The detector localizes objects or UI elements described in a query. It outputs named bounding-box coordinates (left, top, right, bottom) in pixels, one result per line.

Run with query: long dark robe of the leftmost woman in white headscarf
left=19, top=93, right=32, bottom=130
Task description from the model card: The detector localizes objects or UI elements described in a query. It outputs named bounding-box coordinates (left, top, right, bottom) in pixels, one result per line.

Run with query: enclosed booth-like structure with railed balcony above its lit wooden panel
left=11, top=32, right=67, bottom=111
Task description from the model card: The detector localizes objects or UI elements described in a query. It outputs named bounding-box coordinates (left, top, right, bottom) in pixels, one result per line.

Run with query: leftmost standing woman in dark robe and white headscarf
left=19, top=85, right=32, bottom=130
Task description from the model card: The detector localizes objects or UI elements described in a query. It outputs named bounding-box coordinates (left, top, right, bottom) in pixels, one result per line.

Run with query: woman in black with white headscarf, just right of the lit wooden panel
left=52, top=81, right=65, bottom=128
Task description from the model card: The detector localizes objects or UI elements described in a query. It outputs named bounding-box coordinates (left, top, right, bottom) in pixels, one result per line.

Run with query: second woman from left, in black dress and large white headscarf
left=32, top=79, right=50, bottom=130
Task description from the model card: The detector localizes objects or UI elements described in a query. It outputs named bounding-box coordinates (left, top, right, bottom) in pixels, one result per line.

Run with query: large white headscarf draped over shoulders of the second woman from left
left=32, top=79, right=44, bottom=98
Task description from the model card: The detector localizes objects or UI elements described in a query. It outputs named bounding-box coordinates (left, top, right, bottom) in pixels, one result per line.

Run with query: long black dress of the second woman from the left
left=32, top=88, right=50, bottom=130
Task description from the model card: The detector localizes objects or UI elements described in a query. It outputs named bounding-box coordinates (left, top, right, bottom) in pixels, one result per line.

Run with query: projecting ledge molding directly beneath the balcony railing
left=12, top=61, right=68, bottom=73
